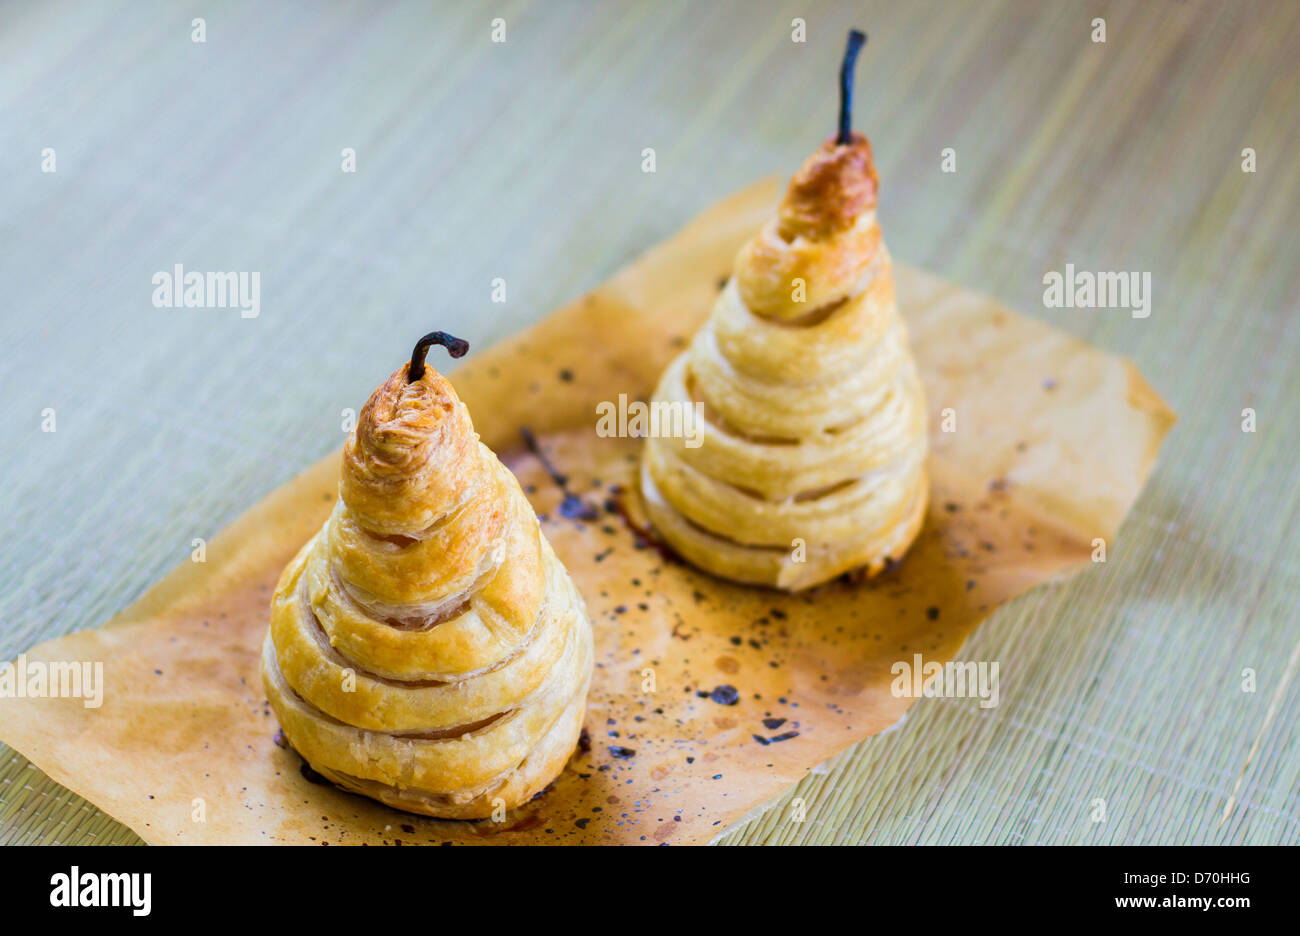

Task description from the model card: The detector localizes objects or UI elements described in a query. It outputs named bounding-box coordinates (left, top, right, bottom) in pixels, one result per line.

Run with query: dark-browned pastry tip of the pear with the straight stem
left=777, top=133, right=879, bottom=242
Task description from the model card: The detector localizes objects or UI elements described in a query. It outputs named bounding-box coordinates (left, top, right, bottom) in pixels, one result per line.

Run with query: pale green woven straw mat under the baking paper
left=0, top=0, right=1300, bottom=844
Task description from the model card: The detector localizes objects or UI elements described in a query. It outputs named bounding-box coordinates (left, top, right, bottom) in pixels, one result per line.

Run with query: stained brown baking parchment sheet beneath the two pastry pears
left=0, top=179, right=1174, bottom=844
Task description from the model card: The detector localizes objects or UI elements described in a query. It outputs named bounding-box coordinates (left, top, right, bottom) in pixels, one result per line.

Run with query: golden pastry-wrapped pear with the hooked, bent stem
left=261, top=333, right=593, bottom=819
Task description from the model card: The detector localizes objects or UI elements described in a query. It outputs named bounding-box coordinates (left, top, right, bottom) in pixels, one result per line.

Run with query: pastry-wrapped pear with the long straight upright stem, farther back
left=641, top=34, right=928, bottom=590
